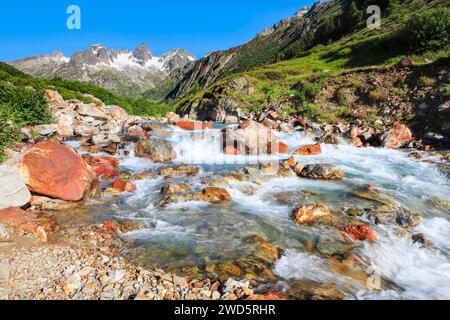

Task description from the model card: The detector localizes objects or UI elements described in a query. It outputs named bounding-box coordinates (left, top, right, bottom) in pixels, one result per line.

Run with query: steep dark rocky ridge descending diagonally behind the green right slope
left=167, top=0, right=349, bottom=99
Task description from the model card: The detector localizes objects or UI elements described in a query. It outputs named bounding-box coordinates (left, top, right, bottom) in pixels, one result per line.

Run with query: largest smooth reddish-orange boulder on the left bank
left=18, top=140, right=98, bottom=201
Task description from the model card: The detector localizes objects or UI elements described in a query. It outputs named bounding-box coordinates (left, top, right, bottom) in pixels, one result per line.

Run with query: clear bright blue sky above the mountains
left=0, top=0, right=313, bottom=61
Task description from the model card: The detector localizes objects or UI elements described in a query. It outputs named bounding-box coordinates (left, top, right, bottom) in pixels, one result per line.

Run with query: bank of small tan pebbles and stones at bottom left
left=0, top=225, right=248, bottom=300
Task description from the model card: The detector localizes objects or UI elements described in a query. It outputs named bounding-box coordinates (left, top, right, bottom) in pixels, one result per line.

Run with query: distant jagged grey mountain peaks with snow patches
left=9, top=44, right=195, bottom=96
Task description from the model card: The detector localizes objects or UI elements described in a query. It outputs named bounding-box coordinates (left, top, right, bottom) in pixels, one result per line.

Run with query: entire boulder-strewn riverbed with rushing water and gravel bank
left=0, top=91, right=450, bottom=300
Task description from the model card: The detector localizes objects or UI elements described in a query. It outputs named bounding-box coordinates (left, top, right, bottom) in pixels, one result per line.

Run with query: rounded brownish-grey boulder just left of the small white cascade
left=135, top=139, right=177, bottom=162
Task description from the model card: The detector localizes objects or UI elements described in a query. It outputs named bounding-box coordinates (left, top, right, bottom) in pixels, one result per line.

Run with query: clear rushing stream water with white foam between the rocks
left=65, top=123, right=450, bottom=299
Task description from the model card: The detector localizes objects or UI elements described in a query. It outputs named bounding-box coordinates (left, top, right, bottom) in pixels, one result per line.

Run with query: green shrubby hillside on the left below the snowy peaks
left=0, top=62, right=168, bottom=160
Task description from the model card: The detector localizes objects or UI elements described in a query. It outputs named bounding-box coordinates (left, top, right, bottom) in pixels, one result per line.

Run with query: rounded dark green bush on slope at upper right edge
left=403, top=7, right=450, bottom=52
